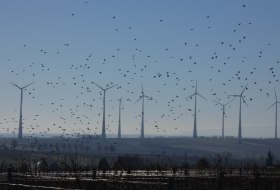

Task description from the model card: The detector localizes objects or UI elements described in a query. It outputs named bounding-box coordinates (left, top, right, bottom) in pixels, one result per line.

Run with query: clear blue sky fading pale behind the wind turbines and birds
left=0, top=0, right=280, bottom=138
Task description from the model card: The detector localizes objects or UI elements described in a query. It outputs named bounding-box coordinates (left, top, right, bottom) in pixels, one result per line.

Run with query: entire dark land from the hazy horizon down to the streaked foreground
left=0, top=137, right=280, bottom=190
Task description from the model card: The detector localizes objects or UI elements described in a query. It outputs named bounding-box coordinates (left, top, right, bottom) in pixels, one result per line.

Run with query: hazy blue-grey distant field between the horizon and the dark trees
left=0, top=137, right=280, bottom=164
